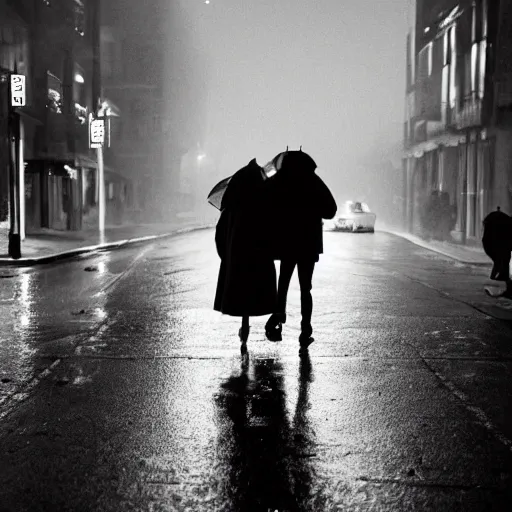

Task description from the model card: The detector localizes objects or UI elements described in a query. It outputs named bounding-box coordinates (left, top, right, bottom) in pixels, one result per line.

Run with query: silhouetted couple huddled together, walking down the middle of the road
left=214, top=150, right=337, bottom=350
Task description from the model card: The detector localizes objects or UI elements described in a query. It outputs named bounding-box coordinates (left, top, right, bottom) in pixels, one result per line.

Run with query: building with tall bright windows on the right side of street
left=403, top=0, right=512, bottom=244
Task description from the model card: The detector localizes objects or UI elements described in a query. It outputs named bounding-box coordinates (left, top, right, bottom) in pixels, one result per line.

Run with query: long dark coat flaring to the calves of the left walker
left=214, top=160, right=277, bottom=316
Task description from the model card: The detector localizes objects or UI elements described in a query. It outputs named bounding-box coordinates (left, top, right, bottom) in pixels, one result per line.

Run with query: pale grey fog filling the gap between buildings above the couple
left=160, top=0, right=407, bottom=226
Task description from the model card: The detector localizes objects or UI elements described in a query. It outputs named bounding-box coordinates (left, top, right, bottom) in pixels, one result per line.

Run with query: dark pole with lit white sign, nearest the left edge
left=8, top=72, right=26, bottom=259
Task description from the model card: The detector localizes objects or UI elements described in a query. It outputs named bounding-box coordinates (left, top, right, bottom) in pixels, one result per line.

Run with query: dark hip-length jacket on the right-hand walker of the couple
left=268, top=152, right=337, bottom=261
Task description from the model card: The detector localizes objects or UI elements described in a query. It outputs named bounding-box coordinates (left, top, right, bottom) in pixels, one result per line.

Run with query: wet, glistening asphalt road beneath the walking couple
left=0, top=230, right=512, bottom=512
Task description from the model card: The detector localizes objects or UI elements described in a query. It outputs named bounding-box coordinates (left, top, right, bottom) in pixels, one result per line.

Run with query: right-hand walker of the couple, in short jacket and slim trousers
left=265, top=151, right=337, bottom=349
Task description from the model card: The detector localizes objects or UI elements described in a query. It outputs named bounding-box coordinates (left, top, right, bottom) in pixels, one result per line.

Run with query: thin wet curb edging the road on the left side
left=0, top=224, right=215, bottom=267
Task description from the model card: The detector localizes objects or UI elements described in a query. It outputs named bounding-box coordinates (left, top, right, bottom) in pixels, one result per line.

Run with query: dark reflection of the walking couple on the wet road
left=215, top=354, right=315, bottom=511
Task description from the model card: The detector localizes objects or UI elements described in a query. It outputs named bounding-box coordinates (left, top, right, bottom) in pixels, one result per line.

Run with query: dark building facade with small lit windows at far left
left=0, top=0, right=130, bottom=251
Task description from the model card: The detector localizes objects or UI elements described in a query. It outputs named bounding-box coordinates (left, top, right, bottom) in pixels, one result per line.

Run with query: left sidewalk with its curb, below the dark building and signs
left=0, top=222, right=210, bottom=266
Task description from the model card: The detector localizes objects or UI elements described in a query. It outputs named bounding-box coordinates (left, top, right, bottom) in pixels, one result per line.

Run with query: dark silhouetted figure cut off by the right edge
left=482, top=206, right=512, bottom=299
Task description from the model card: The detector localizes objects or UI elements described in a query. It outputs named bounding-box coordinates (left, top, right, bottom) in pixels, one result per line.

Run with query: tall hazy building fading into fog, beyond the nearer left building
left=101, top=0, right=206, bottom=221
